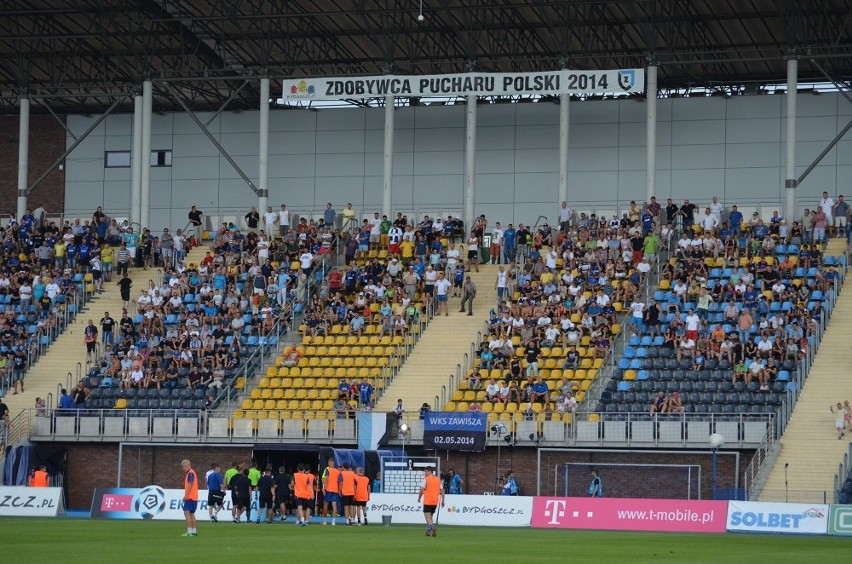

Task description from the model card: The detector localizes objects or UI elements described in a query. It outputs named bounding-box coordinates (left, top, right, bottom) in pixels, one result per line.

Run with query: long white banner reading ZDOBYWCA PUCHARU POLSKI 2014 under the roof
left=282, top=69, right=645, bottom=101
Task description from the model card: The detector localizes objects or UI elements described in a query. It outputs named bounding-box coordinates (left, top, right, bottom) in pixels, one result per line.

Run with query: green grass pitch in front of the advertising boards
left=0, top=518, right=852, bottom=564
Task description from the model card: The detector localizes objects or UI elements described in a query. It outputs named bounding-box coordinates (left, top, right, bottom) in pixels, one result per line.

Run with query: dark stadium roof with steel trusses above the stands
left=0, top=0, right=852, bottom=114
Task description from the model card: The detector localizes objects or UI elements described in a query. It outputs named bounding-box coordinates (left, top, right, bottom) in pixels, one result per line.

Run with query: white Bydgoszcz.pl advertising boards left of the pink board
left=367, top=494, right=533, bottom=527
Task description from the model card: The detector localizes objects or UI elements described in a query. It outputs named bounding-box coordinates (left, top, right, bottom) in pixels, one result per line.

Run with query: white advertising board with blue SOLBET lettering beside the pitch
left=727, top=501, right=828, bottom=535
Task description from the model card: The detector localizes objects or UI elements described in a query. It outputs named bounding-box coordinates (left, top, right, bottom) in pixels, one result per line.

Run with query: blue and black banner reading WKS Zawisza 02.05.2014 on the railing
left=423, top=411, right=488, bottom=452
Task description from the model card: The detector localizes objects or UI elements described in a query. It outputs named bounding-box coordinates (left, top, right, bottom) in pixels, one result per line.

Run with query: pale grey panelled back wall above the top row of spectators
left=65, top=94, right=852, bottom=229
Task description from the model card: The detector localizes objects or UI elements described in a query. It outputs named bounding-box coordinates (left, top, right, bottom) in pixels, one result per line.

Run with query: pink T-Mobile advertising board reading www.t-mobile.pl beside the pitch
left=532, top=497, right=727, bottom=533
